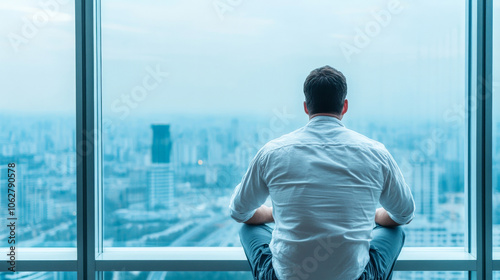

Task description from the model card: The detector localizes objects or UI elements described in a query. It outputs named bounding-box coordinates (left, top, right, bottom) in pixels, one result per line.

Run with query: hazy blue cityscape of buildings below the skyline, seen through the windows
left=0, top=112, right=500, bottom=280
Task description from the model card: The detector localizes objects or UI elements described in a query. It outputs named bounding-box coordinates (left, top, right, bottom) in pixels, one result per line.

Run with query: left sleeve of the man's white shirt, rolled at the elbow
left=229, top=151, right=269, bottom=223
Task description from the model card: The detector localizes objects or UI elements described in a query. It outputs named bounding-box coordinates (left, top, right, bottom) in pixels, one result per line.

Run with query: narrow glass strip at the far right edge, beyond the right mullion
left=492, top=0, right=500, bottom=252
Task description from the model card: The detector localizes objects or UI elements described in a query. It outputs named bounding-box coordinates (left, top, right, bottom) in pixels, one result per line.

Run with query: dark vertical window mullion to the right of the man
left=469, top=0, right=493, bottom=280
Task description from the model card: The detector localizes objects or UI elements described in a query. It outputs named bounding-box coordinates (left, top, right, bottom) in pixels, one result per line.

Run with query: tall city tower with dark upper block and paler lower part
left=147, top=124, right=174, bottom=210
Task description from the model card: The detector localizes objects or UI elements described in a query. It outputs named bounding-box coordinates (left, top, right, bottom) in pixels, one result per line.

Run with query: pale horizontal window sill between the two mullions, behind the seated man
left=96, top=247, right=476, bottom=271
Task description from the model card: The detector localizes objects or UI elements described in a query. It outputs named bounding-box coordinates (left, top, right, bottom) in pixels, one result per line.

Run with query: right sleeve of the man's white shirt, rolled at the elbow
left=380, top=152, right=415, bottom=225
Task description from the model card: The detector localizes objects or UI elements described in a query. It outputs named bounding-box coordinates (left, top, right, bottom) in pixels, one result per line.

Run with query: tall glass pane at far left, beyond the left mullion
left=0, top=0, right=76, bottom=247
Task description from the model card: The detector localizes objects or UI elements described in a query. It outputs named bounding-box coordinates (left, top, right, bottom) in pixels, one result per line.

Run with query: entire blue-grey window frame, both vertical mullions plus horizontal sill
left=0, top=0, right=492, bottom=280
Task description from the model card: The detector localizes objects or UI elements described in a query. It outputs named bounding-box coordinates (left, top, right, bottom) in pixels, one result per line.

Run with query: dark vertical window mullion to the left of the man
left=75, top=0, right=97, bottom=280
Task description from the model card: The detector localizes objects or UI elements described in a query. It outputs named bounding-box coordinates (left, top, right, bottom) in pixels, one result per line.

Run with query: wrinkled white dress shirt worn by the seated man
left=229, top=116, right=415, bottom=280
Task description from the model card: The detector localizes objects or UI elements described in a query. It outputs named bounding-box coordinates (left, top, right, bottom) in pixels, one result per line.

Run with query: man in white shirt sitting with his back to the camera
left=229, top=66, right=415, bottom=280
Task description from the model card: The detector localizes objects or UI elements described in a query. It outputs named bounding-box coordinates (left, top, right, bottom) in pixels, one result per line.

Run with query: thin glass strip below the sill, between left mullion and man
left=104, top=271, right=253, bottom=280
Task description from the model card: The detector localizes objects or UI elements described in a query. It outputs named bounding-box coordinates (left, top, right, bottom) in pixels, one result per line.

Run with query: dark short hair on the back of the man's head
left=304, top=65, right=347, bottom=115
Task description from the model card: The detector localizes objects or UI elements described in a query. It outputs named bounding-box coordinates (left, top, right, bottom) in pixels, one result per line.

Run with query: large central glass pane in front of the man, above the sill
left=102, top=0, right=466, bottom=246
